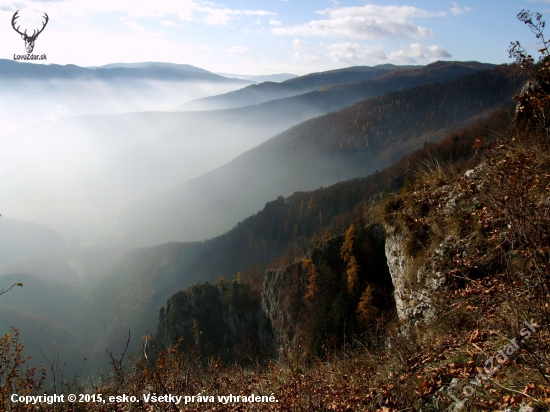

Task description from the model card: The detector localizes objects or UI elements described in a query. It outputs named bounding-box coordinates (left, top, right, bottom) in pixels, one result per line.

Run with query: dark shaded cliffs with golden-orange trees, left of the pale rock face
left=157, top=224, right=395, bottom=357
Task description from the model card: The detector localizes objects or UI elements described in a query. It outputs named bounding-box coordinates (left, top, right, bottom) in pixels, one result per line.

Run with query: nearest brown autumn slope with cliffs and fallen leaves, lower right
left=47, top=34, right=550, bottom=411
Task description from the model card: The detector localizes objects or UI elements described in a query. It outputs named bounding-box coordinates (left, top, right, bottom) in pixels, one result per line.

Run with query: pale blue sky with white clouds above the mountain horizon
left=0, top=0, right=550, bottom=75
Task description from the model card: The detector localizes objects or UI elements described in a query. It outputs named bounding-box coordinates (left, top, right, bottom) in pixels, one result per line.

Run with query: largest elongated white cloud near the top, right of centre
left=272, top=4, right=445, bottom=39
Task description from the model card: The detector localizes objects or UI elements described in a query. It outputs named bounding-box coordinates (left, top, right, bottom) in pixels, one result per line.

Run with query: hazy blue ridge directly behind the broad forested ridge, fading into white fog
left=0, top=62, right=496, bottom=244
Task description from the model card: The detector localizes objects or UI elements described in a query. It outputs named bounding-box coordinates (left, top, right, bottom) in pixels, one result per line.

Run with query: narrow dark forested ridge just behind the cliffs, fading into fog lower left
left=0, top=105, right=511, bottom=375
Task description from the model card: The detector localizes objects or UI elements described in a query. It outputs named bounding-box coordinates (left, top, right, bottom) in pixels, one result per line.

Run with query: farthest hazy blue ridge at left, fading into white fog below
left=0, top=59, right=253, bottom=135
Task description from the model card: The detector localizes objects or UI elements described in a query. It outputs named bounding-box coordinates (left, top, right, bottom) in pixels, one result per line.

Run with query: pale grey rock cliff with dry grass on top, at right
left=384, top=163, right=485, bottom=325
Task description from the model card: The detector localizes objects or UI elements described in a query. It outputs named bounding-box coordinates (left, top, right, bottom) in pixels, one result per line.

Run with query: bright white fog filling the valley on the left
left=0, top=60, right=274, bottom=374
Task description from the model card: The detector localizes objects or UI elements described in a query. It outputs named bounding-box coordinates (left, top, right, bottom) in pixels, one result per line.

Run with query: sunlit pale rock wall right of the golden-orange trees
left=384, top=167, right=485, bottom=324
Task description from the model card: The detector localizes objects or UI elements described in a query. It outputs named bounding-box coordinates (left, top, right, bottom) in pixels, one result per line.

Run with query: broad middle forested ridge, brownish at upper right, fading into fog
left=117, top=65, right=525, bottom=245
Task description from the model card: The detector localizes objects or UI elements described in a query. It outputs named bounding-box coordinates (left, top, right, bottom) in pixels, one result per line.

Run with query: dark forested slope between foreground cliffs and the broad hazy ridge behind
left=89, top=111, right=510, bottom=364
